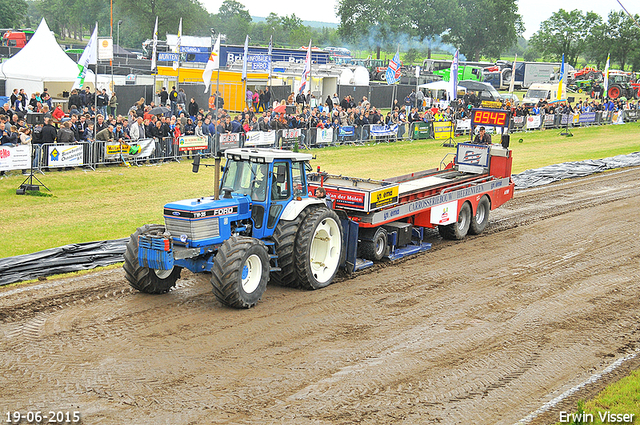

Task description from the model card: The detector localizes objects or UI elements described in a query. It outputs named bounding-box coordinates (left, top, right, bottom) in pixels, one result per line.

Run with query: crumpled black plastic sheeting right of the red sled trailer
left=512, top=152, right=640, bottom=189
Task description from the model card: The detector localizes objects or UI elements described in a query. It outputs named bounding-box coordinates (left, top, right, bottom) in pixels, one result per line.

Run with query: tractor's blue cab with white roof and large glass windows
left=220, top=148, right=312, bottom=239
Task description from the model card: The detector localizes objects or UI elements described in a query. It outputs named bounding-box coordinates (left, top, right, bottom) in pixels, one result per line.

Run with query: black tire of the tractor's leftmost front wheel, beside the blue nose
left=123, top=224, right=182, bottom=294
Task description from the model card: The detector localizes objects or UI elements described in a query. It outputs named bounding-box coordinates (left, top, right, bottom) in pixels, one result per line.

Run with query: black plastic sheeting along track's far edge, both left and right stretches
left=0, top=152, right=640, bottom=286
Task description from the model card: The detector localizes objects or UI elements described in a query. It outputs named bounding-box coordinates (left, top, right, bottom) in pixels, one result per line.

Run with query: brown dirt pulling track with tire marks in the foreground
left=0, top=168, right=640, bottom=424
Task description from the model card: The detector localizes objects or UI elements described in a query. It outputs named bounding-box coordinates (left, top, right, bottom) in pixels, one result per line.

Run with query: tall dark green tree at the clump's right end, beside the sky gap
left=442, top=0, right=524, bottom=61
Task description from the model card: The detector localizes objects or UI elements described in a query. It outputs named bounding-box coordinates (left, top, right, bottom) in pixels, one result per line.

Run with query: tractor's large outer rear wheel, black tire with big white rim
left=295, top=208, right=343, bottom=289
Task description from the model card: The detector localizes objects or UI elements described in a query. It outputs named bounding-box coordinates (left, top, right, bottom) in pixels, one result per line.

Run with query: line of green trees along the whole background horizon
left=0, top=0, right=640, bottom=69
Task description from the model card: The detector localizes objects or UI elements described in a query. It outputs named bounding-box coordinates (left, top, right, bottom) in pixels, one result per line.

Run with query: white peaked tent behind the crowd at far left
left=0, top=18, right=106, bottom=97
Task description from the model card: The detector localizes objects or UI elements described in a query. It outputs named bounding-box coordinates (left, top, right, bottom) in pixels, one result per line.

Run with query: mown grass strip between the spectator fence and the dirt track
left=0, top=123, right=640, bottom=258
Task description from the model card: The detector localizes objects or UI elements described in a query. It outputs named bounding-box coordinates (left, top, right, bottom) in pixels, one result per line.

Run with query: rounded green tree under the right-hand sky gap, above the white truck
left=529, top=9, right=602, bottom=67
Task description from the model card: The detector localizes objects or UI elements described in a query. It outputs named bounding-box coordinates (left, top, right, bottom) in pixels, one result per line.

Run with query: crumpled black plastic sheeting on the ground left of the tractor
left=0, top=238, right=129, bottom=286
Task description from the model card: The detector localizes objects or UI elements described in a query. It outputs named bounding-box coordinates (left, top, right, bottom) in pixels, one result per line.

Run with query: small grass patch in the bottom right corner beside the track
left=558, top=370, right=640, bottom=425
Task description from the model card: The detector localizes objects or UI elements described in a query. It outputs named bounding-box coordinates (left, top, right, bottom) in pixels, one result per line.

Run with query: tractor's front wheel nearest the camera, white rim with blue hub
left=211, top=236, right=270, bottom=308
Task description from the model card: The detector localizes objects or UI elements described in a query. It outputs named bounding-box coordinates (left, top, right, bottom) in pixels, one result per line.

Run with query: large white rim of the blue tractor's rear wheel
left=309, top=218, right=342, bottom=283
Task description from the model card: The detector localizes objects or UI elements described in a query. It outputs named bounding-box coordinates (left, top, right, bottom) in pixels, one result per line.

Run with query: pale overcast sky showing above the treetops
left=201, top=0, right=640, bottom=39
